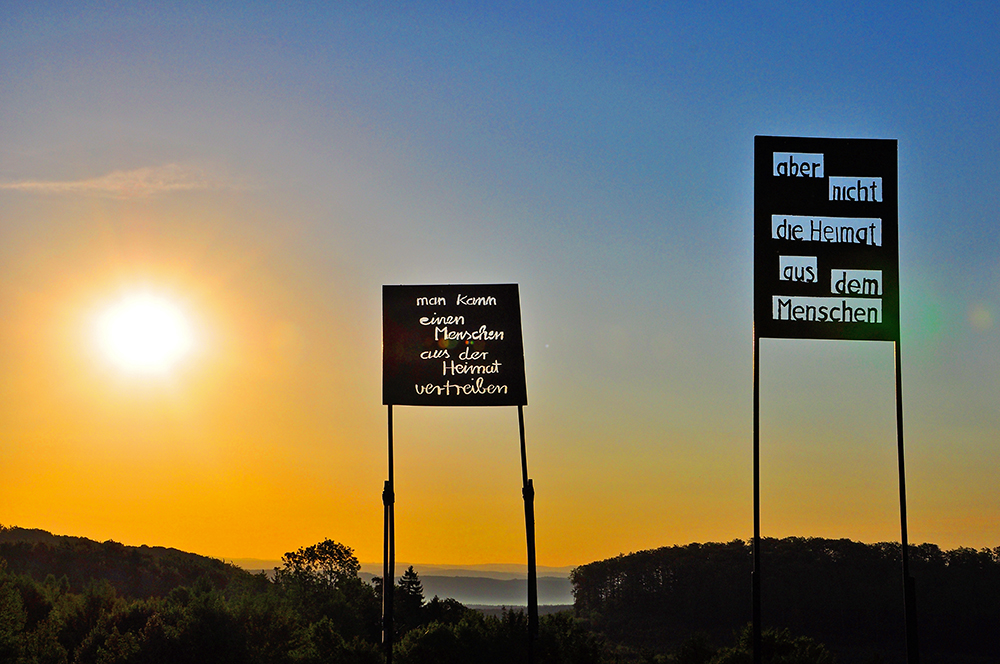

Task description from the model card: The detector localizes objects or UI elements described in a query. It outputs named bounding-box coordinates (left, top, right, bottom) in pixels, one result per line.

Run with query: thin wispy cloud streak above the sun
left=0, top=164, right=232, bottom=199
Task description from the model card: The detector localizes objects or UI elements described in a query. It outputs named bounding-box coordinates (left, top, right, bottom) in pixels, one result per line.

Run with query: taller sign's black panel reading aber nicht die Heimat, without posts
left=754, top=136, right=899, bottom=341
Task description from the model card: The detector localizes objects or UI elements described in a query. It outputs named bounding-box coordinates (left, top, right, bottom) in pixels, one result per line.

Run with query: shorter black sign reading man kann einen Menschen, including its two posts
left=382, top=284, right=538, bottom=664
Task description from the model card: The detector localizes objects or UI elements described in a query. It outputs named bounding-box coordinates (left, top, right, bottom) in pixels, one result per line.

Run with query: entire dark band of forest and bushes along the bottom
left=0, top=526, right=1000, bottom=664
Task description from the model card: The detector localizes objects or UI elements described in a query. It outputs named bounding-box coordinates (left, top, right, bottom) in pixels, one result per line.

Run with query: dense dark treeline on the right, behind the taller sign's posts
left=571, top=538, right=1000, bottom=663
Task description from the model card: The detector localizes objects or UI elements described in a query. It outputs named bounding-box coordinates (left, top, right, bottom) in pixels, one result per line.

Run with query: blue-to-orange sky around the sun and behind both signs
left=0, top=1, right=1000, bottom=567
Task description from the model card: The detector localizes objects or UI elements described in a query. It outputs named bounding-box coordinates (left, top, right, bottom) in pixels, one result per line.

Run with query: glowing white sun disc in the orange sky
left=94, top=292, right=194, bottom=374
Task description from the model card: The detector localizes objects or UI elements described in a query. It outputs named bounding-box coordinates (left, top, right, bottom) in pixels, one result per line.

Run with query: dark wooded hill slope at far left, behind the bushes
left=0, top=526, right=254, bottom=598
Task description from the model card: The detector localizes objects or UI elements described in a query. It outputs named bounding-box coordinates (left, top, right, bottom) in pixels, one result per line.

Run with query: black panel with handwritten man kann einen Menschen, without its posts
left=382, top=284, right=528, bottom=406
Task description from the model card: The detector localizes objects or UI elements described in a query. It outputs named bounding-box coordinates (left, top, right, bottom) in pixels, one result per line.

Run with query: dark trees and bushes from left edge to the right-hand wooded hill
left=0, top=528, right=612, bottom=664
